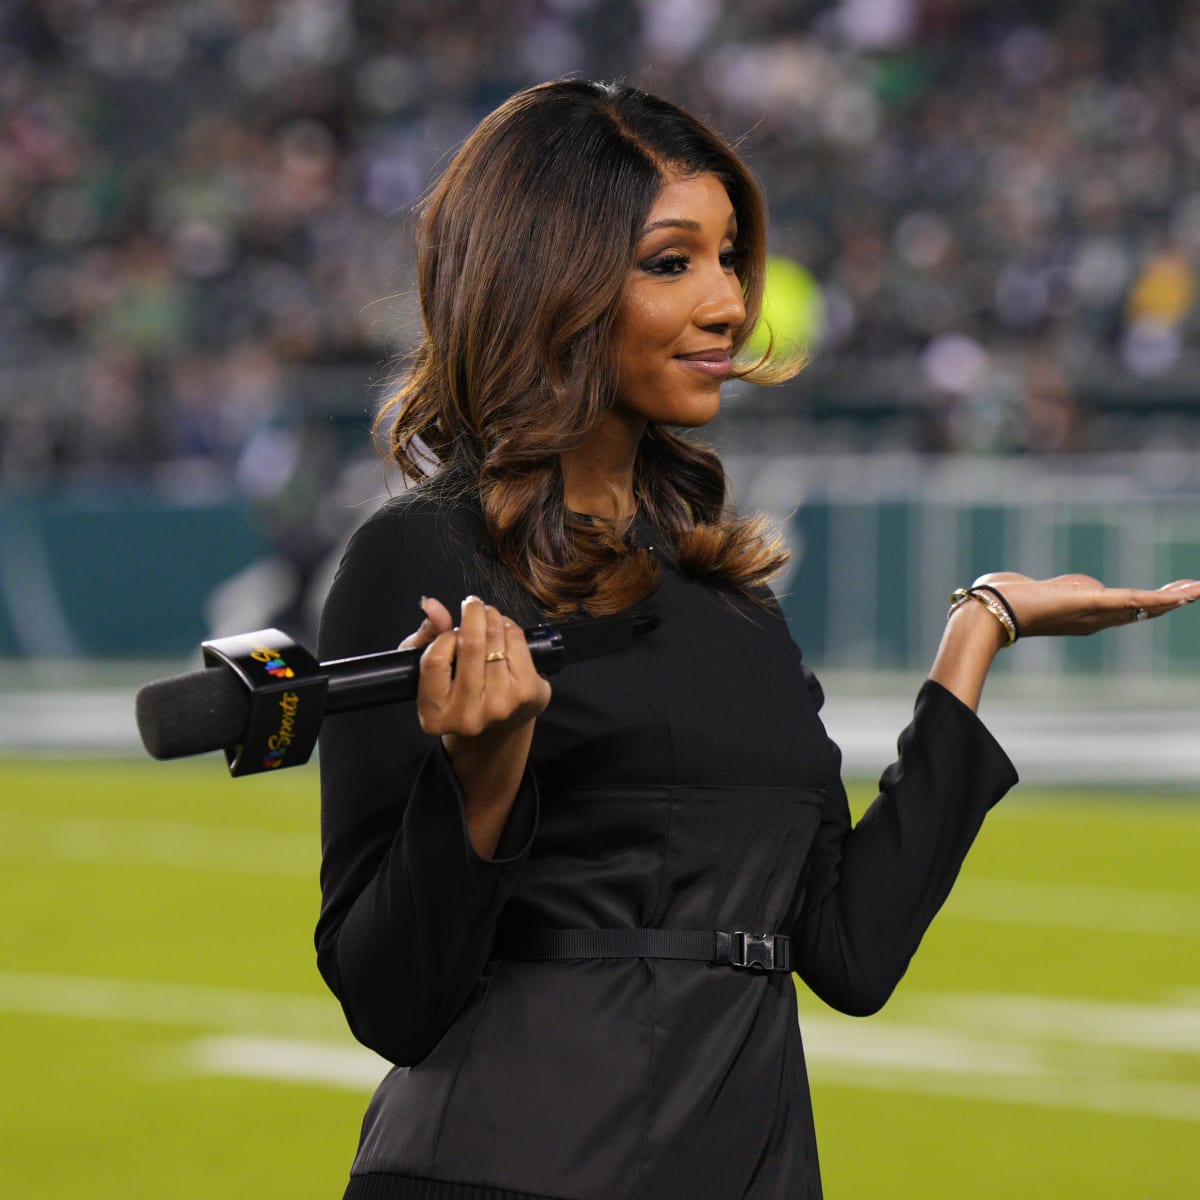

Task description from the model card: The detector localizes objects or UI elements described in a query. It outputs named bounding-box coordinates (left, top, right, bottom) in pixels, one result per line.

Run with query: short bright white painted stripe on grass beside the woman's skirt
left=185, top=1037, right=391, bottom=1092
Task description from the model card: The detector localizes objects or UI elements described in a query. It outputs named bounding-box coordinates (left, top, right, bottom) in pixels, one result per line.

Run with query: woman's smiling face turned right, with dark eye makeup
left=616, top=175, right=746, bottom=426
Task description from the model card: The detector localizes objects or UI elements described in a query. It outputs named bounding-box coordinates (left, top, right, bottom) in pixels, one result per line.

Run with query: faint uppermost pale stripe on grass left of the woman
left=0, top=816, right=320, bottom=880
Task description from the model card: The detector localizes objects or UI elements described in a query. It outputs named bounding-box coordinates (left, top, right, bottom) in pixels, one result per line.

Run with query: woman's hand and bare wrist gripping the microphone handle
left=400, top=596, right=550, bottom=858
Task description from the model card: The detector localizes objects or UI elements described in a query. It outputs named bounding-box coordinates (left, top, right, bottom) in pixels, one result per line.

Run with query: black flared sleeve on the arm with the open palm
left=793, top=677, right=1016, bottom=1016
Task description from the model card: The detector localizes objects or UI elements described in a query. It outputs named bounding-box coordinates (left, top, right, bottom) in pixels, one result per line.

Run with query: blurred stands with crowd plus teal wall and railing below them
left=7, top=0, right=1200, bottom=672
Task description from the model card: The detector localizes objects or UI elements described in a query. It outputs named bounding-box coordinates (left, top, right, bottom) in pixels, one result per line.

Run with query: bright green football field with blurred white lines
left=0, top=757, right=1200, bottom=1200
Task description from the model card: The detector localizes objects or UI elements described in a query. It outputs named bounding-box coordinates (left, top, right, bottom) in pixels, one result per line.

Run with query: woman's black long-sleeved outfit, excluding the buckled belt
left=317, top=490, right=1015, bottom=1200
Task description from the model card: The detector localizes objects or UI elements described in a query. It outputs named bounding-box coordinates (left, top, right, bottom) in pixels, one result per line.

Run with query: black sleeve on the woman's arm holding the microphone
left=316, top=502, right=538, bottom=1064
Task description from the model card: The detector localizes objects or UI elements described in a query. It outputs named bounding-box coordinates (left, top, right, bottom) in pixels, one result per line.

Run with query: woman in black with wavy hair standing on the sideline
left=317, top=82, right=1200, bottom=1200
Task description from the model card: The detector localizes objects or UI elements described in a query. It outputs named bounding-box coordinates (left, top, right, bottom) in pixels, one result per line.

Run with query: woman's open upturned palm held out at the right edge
left=972, top=571, right=1200, bottom=637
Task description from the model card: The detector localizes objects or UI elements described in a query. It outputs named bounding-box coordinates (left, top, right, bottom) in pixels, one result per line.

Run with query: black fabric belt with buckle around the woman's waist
left=492, top=929, right=792, bottom=971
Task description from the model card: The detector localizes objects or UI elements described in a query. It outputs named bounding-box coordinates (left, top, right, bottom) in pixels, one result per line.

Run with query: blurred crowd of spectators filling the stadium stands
left=0, top=0, right=1200, bottom=496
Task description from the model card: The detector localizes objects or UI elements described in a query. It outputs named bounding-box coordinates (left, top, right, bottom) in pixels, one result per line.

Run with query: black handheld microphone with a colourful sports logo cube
left=136, top=613, right=658, bottom=775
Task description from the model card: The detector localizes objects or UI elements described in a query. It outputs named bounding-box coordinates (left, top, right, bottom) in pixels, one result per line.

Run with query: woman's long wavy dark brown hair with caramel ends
left=376, top=80, right=786, bottom=617
